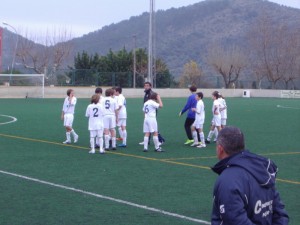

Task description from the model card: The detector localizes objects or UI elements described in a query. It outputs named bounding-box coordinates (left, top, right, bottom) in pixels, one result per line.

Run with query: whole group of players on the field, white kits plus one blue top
left=61, top=83, right=227, bottom=154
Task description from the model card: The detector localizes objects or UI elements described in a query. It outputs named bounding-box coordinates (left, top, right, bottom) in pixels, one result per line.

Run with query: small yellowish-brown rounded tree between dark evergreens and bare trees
left=179, top=60, right=203, bottom=87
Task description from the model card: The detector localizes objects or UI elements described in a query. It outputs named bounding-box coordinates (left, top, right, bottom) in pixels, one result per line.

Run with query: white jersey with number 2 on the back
left=85, top=103, right=103, bottom=130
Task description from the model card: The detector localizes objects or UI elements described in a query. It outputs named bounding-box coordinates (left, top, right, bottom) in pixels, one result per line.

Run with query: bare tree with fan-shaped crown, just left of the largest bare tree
left=207, top=45, right=247, bottom=88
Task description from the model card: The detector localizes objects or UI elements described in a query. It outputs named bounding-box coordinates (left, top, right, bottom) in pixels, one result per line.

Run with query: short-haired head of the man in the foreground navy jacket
left=217, top=126, right=245, bottom=156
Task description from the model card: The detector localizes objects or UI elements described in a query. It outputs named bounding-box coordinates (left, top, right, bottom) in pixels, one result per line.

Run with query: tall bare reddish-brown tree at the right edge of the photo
left=249, top=14, right=300, bottom=89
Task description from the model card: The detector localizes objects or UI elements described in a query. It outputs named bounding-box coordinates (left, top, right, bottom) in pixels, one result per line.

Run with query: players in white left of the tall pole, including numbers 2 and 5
left=62, top=87, right=127, bottom=154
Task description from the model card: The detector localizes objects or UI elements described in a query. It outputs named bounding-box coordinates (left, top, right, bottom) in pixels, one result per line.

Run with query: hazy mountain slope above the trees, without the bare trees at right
left=3, top=0, right=300, bottom=76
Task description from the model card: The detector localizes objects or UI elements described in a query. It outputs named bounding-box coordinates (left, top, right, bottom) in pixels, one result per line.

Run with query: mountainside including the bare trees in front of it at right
left=2, top=0, right=300, bottom=88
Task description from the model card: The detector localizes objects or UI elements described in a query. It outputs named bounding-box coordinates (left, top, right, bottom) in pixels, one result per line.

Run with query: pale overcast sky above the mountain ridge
left=0, top=0, right=300, bottom=40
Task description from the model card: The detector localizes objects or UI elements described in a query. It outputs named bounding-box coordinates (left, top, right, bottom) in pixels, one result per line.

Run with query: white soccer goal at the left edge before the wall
left=0, top=74, right=45, bottom=98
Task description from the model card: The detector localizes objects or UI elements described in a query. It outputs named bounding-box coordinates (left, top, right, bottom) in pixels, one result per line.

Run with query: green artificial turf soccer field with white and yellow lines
left=0, top=97, right=300, bottom=225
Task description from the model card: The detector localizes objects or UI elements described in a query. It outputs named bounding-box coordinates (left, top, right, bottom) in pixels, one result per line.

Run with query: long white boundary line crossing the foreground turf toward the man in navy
left=0, top=170, right=211, bottom=224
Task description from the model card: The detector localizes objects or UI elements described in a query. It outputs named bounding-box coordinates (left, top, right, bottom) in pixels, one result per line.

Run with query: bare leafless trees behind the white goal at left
left=17, top=29, right=71, bottom=83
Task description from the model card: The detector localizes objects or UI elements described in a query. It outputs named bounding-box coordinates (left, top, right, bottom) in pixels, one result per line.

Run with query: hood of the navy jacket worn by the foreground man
left=212, top=150, right=278, bottom=188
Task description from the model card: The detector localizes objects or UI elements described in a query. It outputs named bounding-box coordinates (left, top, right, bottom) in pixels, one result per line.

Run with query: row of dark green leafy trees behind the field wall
left=69, top=48, right=174, bottom=87
